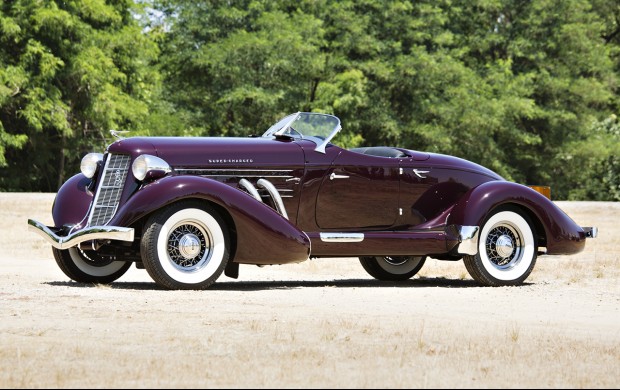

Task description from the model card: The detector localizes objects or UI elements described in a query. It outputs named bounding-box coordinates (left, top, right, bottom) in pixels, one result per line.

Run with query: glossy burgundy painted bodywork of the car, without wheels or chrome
left=47, top=133, right=585, bottom=264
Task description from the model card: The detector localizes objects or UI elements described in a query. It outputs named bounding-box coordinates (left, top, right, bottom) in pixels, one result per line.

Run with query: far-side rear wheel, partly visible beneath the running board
left=360, top=256, right=426, bottom=281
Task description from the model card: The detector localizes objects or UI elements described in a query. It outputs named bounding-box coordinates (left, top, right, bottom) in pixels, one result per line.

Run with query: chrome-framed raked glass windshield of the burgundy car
left=263, top=112, right=341, bottom=153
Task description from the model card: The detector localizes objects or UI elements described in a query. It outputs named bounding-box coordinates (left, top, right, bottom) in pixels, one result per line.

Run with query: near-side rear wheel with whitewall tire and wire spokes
left=463, top=209, right=537, bottom=287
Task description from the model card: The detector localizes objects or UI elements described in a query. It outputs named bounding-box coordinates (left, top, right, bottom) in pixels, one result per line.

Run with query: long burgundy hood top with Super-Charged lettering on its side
left=108, top=137, right=304, bottom=168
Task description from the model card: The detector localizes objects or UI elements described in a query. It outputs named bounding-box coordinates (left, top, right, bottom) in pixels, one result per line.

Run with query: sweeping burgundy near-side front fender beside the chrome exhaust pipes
left=109, top=176, right=310, bottom=264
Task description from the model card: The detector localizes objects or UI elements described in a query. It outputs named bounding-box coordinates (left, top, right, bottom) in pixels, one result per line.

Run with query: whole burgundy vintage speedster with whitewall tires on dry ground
left=28, top=112, right=597, bottom=289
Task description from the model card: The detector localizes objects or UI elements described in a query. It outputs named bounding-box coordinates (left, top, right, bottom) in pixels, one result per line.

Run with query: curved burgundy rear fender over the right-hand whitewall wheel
left=447, top=181, right=586, bottom=254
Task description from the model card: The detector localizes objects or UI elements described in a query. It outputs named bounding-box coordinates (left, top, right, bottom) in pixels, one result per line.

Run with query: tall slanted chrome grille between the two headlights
left=88, top=154, right=131, bottom=226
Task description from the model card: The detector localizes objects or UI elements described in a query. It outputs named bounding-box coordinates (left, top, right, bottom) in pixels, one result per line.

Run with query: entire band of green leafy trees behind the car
left=0, top=0, right=620, bottom=200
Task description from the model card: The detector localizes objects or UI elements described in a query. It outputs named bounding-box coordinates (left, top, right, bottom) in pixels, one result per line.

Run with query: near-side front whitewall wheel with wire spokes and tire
left=140, top=202, right=229, bottom=290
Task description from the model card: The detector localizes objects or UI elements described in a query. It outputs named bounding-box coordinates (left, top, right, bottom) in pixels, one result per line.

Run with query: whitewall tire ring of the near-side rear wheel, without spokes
left=476, top=210, right=537, bottom=284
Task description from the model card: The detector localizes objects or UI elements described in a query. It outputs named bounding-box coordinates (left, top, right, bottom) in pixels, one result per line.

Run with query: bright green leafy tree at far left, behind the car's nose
left=0, top=0, right=157, bottom=191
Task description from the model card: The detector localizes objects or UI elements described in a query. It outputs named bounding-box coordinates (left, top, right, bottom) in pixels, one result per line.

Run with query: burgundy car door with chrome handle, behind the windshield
left=316, top=150, right=400, bottom=230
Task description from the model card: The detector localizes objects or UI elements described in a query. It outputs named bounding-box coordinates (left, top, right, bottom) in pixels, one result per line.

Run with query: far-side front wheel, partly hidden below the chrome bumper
left=52, top=247, right=131, bottom=284
